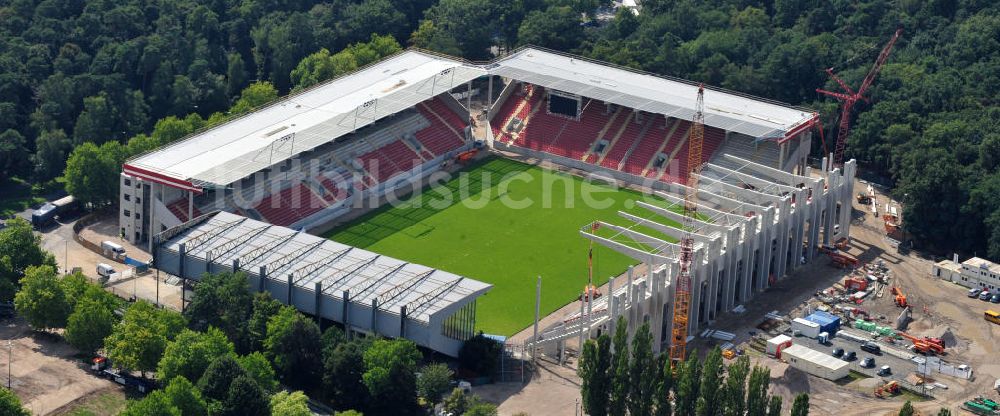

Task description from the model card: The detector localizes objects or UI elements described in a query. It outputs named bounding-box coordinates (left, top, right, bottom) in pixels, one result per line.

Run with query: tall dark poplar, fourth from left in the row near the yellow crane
left=628, top=322, right=656, bottom=416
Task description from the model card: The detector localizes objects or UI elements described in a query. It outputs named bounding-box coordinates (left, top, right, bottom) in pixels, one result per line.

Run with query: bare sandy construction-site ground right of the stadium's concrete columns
left=490, top=177, right=1000, bottom=416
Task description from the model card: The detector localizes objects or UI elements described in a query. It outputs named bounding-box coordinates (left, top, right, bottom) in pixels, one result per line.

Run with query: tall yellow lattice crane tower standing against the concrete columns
left=670, top=85, right=705, bottom=365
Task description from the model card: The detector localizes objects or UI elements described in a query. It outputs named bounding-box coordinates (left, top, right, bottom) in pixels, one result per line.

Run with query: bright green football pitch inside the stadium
left=326, top=158, right=676, bottom=335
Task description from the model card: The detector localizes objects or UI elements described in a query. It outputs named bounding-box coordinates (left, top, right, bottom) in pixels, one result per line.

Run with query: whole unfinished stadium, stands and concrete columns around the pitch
left=129, top=48, right=855, bottom=356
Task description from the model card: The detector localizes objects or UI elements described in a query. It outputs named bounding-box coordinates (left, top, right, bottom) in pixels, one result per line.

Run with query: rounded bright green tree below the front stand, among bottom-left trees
left=156, top=327, right=234, bottom=380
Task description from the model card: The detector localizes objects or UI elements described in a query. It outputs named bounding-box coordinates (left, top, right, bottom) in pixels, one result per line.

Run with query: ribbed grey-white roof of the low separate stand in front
left=161, top=211, right=493, bottom=323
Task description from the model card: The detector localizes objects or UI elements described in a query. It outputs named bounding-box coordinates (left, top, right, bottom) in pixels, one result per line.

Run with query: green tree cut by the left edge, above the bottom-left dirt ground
left=0, top=218, right=56, bottom=284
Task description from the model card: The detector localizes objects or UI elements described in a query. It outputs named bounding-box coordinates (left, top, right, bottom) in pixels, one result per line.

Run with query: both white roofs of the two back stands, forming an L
left=123, top=48, right=815, bottom=192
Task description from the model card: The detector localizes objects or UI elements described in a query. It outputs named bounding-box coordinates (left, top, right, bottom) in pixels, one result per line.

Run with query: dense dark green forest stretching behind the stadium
left=0, top=0, right=1000, bottom=259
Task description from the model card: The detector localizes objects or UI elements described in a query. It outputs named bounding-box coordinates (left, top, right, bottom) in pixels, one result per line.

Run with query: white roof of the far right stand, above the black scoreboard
left=489, top=48, right=814, bottom=138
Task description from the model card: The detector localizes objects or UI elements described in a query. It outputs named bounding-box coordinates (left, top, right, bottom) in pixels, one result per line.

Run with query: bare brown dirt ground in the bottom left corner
left=0, top=319, right=118, bottom=415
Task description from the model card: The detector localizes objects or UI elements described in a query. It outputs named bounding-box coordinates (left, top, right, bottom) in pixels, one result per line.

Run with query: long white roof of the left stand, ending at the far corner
left=124, top=50, right=486, bottom=189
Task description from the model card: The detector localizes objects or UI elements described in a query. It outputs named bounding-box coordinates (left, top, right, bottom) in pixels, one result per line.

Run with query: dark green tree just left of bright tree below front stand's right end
left=323, top=340, right=368, bottom=409
